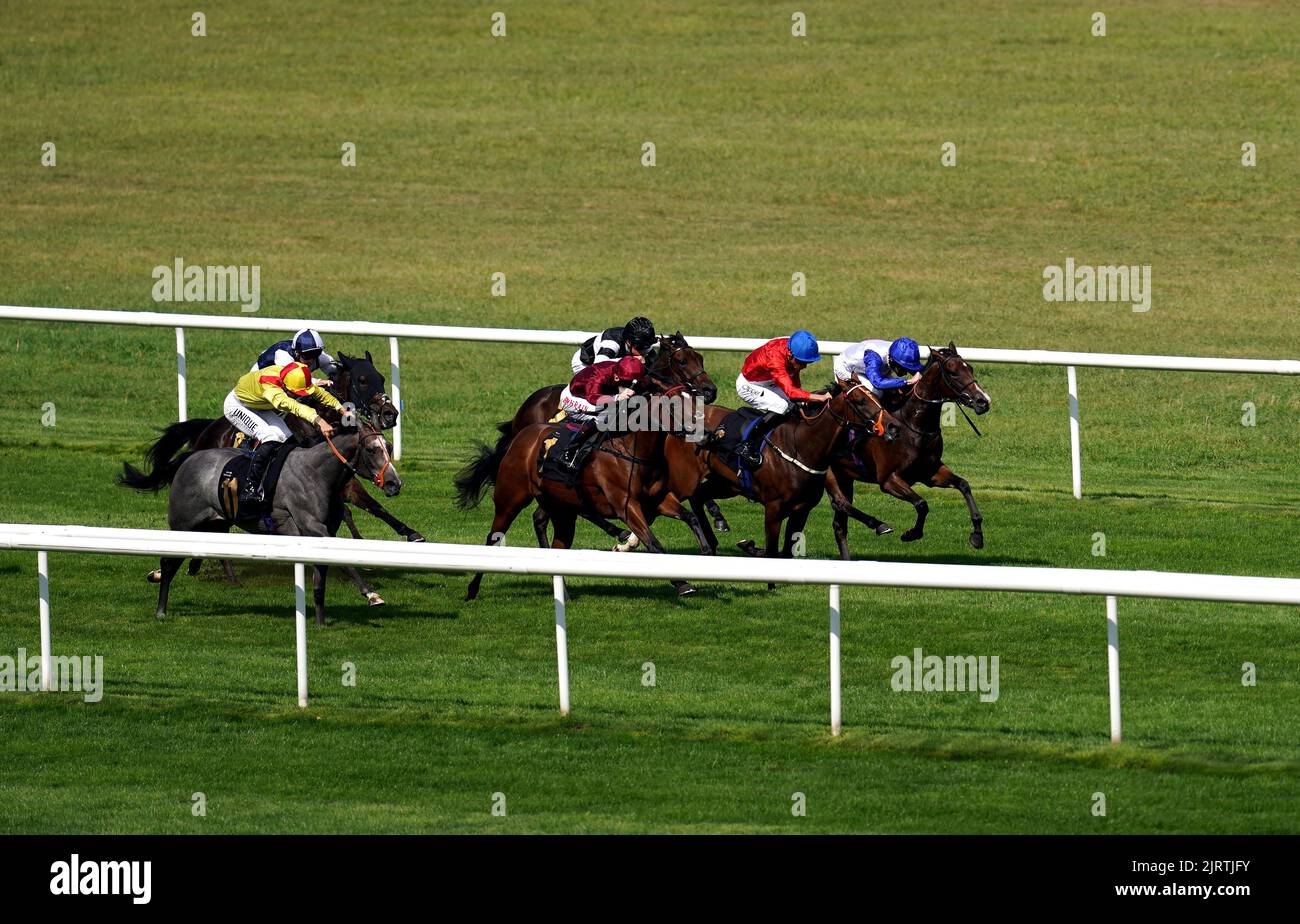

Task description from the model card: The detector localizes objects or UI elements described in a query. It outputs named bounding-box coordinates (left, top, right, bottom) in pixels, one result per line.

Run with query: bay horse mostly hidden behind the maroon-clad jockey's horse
left=455, top=330, right=729, bottom=551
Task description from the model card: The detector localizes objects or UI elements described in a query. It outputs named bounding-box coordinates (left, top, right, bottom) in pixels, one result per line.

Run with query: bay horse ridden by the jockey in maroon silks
left=459, top=385, right=703, bottom=600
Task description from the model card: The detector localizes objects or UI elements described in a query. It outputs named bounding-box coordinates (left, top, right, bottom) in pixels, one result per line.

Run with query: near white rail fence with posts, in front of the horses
left=0, top=524, right=1300, bottom=743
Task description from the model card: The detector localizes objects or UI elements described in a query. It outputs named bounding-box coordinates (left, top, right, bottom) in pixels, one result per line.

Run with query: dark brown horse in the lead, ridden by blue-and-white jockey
left=826, top=343, right=989, bottom=560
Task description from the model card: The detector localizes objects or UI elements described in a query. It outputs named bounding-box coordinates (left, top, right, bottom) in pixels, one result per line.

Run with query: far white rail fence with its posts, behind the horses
left=0, top=305, right=1300, bottom=498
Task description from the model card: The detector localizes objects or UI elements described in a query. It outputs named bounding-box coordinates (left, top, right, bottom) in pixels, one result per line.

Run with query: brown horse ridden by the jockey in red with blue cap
left=666, top=382, right=880, bottom=574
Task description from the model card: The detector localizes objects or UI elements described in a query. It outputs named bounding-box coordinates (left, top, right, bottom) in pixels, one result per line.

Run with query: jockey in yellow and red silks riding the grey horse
left=225, top=363, right=342, bottom=503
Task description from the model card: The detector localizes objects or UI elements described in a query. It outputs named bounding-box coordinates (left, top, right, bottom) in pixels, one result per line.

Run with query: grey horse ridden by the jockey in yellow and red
left=117, top=424, right=402, bottom=625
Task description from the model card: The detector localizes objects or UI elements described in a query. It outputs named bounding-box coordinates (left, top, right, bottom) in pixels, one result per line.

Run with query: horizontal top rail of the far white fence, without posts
left=0, top=305, right=1300, bottom=376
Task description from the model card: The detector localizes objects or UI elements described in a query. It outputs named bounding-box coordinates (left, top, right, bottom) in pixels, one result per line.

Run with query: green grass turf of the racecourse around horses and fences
left=0, top=1, right=1300, bottom=833
